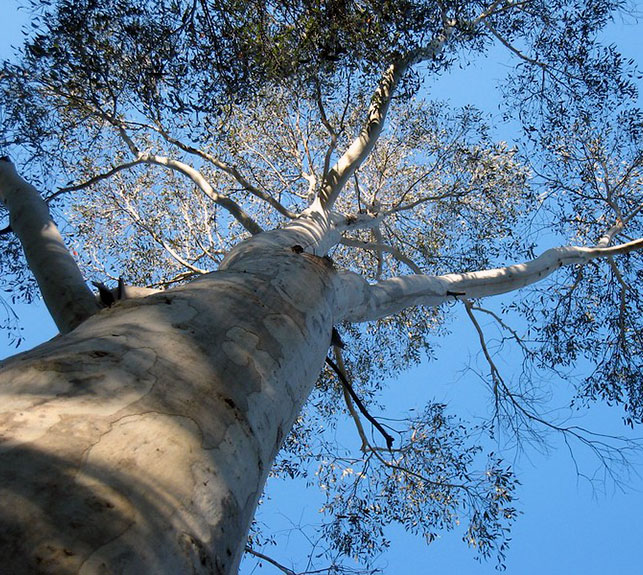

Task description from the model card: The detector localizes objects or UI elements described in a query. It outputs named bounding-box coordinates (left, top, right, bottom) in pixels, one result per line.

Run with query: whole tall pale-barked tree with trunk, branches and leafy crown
left=0, top=0, right=643, bottom=573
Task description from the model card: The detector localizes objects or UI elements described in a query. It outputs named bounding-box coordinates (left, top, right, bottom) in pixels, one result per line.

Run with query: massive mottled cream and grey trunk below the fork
left=0, top=245, right=334, bottom=575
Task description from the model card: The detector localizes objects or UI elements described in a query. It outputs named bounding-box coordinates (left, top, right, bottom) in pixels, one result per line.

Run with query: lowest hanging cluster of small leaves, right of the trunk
left=319, top=404, right=516, bottom=563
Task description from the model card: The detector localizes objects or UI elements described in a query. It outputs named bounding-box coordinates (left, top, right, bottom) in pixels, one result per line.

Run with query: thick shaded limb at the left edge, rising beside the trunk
left=0, top=159, right=99, bottom=333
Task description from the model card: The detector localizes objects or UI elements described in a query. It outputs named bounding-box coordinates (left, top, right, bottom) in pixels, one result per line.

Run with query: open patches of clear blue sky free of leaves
left=0, top=0, right=643, bottom=575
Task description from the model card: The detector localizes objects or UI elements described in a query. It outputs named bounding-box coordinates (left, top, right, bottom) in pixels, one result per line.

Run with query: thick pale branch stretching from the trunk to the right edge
left=336, top=239, right=643, bottom=322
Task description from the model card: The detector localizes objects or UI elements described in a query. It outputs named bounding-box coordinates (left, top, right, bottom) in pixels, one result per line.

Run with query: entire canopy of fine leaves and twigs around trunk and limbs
left=0, top=0, right=643, bottom=572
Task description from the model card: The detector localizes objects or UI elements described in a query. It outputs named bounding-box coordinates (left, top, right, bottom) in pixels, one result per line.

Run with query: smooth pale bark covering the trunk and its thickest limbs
left=0, top=7, right=632, bottom=575
